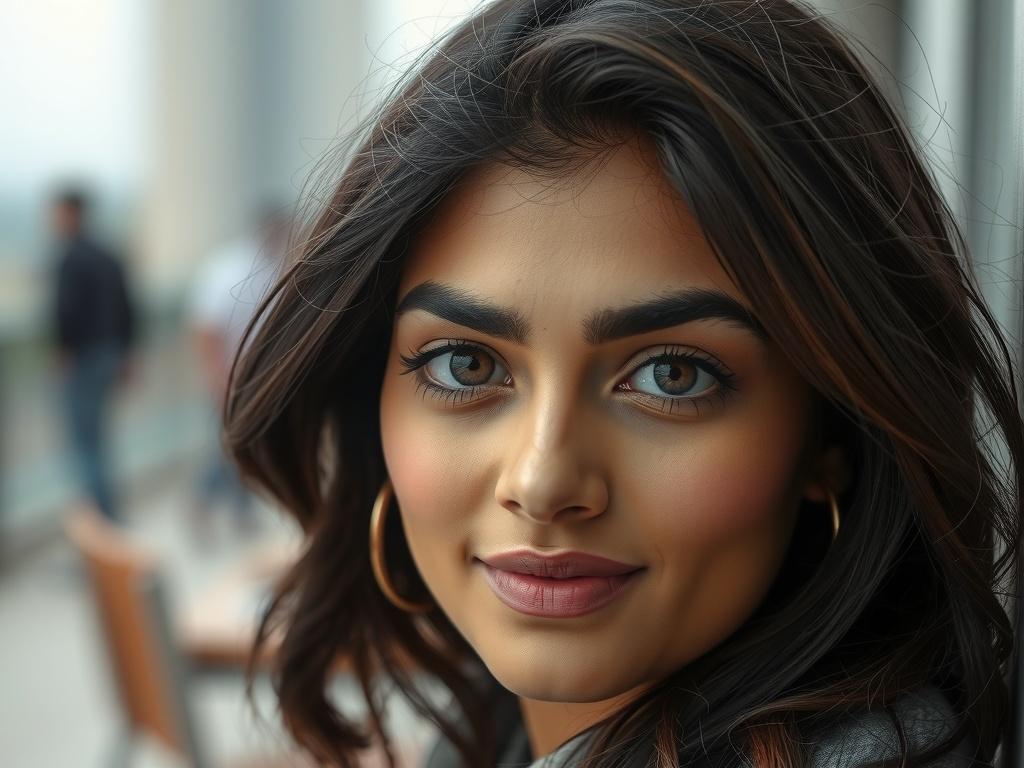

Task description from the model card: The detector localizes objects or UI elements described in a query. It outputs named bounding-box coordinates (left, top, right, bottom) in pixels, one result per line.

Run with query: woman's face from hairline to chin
left=380, top=141, right=815, bottom=701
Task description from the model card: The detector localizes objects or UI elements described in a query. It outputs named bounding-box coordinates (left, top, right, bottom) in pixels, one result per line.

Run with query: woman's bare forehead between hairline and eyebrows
left=398, top=139, right=746, bottom=313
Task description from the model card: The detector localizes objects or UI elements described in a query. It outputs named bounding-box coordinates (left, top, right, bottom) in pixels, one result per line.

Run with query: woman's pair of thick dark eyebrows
left=395, top=281, right=768, bottom=346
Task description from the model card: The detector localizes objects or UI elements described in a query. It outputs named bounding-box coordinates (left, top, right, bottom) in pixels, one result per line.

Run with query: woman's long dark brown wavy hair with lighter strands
left=224, top=0, right=1024, bottom=768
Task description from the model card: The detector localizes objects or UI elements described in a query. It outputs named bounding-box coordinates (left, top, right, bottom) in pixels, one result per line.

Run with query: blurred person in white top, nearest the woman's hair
left=188, top=205, right=291, bottom=540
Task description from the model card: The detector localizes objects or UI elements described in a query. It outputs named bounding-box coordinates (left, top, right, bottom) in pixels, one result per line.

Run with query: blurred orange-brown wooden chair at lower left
left=65, top=507, right=307, bottom=768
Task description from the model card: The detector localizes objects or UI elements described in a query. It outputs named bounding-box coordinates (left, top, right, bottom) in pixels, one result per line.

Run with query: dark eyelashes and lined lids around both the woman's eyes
left=399, top=339, right=736, bottom=416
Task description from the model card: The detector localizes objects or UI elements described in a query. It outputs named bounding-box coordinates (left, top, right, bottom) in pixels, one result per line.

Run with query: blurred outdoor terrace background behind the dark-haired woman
left=0, top=0, right=1024, bottom=766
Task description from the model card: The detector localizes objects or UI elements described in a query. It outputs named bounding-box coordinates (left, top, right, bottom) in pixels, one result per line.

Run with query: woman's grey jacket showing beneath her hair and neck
left=424, top=686, right=978, bottom=768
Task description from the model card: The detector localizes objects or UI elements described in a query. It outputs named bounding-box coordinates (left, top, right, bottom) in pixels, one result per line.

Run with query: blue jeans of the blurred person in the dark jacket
left=65, top=343, right=123, bottom=522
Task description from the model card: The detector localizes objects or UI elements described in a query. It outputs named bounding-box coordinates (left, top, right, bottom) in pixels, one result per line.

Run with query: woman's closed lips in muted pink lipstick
left=477, top=550, right=643, bottom=618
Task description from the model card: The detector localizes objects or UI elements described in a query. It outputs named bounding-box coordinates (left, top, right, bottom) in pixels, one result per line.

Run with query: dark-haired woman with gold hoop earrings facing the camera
left=226, top=0, right=1024, bottom=768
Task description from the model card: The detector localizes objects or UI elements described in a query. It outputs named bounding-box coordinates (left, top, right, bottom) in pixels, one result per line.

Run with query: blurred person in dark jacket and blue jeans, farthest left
left=51, top=186, right=135, bottom=522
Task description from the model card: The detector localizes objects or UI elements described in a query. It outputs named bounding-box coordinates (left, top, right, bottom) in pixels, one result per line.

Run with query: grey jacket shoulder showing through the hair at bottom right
left=808, top=685, right=975, bottom=768
